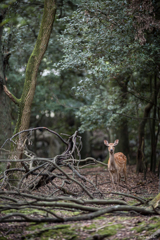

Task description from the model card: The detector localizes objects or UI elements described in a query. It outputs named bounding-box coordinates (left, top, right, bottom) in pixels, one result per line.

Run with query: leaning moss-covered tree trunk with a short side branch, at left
left=4, top=0, right=56, bottom=159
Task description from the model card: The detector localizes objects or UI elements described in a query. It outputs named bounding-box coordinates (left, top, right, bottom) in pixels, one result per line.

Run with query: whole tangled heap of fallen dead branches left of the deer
left=0, top=127, right=159, bottom=227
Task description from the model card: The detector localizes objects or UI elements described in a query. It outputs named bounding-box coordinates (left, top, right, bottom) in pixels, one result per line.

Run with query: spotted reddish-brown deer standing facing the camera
left=104, top=139, right=127, bottom=189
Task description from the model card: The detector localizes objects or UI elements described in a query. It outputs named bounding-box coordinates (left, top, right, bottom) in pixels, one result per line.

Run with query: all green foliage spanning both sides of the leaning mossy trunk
left=3, top=0, right=160, bottom=155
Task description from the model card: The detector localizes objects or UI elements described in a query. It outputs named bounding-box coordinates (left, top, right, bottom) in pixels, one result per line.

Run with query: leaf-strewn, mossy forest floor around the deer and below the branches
left=0, top=165, right=160, bottom=240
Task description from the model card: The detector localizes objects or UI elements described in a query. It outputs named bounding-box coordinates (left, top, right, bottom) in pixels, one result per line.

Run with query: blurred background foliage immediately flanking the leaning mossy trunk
left=3, top=1, right=81, bottom=131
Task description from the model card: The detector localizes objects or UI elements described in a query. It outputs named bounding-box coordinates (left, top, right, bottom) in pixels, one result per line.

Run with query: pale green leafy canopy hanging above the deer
left=56, top=0, right=159, bottom=131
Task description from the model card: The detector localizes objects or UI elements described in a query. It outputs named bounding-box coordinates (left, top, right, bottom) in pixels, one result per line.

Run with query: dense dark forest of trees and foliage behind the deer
left=0, top=0, right=160, bottom=172
